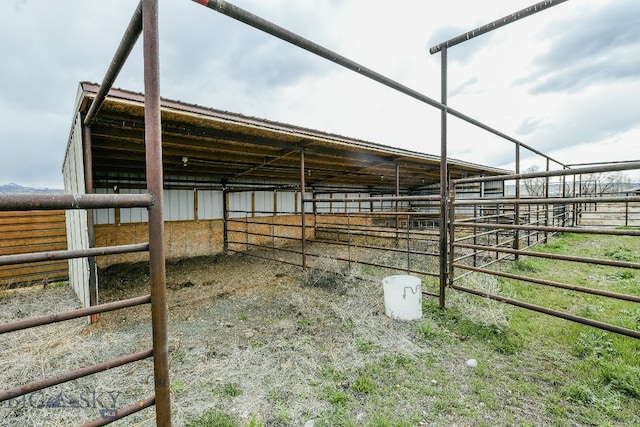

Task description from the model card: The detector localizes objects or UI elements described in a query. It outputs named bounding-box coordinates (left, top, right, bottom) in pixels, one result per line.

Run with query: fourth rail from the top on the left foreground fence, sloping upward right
left=0, top=349, right=153, bottom=402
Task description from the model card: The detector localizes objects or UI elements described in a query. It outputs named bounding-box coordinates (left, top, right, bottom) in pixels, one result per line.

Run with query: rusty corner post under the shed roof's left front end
left=82, top=124, right=98, bottom=323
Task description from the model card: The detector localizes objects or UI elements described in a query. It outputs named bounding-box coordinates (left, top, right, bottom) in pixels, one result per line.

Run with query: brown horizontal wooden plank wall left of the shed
left=0, top=211, right=69, bottom=288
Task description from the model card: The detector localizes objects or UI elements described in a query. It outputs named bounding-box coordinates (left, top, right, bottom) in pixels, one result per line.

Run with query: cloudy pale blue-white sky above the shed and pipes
left=0, top=0, right=640, bottom=188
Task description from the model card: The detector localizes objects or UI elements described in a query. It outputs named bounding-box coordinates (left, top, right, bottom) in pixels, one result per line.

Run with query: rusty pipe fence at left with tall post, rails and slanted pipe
left=0, top=0, right=171, bottom=426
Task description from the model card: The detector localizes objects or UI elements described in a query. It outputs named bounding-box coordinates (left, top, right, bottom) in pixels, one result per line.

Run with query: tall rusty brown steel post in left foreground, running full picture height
left=142, top=0, right=171, bottom=427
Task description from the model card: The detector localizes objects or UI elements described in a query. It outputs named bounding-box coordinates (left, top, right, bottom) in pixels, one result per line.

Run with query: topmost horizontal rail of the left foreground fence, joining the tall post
left=0, top=194, right=153, bottom=211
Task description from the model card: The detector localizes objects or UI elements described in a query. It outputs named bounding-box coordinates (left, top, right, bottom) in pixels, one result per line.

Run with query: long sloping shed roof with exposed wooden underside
left=72, top=82, right=507, bottom=192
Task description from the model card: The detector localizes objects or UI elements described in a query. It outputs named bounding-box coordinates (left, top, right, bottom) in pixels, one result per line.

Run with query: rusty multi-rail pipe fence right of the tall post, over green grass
left=447, top=163, right=640, bottom=338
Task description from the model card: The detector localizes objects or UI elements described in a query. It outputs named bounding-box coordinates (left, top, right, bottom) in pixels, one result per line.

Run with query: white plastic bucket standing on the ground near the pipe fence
left=382, top=274, right=422, bottom=320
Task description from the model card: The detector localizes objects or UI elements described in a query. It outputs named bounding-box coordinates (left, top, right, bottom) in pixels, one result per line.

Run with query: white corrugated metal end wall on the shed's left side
left=62, top=113, right=89, bottom=307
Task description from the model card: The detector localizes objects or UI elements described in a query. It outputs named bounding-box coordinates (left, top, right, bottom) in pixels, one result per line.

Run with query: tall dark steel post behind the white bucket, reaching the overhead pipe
left=439, top=47, right=448, bottom=308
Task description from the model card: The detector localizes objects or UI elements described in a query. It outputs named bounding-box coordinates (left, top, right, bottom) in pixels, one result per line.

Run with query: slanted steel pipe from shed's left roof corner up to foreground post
left=84, top=1, right=142, bottom=126
